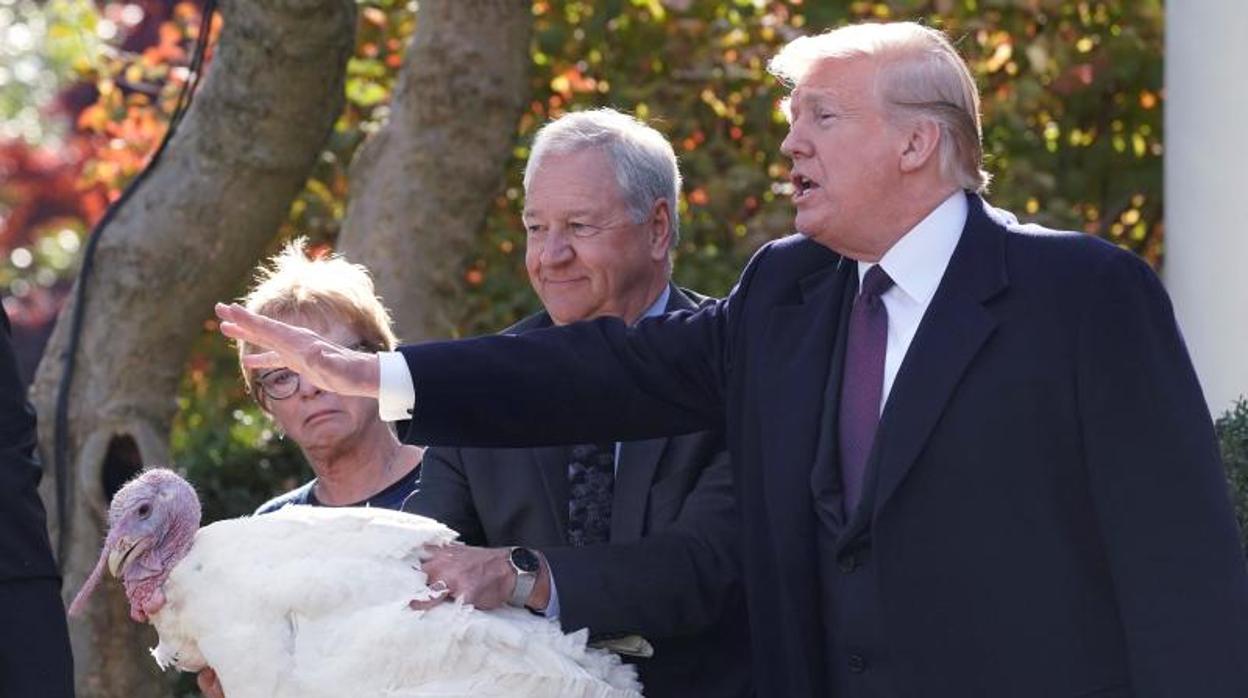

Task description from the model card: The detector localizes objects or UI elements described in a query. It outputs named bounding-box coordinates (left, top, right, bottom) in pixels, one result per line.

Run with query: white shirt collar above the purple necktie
left=857, top=190, right=967, bottom=303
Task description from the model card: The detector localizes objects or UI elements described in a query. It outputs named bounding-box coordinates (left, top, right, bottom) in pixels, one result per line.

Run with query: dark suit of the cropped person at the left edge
left=0, top=308, right=74, bottom=698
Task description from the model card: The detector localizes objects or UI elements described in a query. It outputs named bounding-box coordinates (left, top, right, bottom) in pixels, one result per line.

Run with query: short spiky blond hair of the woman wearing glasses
left=238, top=237, right=398, bottom=396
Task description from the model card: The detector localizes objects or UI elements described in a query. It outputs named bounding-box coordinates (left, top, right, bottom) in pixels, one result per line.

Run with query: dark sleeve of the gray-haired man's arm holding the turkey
left=542, top=439, right=740, bottom=639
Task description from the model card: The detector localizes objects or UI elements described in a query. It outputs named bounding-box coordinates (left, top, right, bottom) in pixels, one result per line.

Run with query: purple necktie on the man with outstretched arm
left=840, top=265, right=892, bottom=516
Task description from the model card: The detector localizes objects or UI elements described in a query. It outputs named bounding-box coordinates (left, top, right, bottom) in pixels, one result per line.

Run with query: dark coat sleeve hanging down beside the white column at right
left=1077, top=255, right=1248, bottom=698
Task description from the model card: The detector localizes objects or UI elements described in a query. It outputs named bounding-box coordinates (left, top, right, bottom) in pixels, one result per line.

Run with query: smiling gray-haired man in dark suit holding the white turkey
left=404, top=109, right=750, bottom=698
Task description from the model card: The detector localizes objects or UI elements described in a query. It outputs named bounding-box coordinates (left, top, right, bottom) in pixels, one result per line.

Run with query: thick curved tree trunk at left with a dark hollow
left=32, top=0, right=356, bottom=698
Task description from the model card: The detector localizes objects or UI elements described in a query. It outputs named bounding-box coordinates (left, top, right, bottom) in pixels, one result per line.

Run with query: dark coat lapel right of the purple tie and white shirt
left=872, top=195, right=1008, bottom=514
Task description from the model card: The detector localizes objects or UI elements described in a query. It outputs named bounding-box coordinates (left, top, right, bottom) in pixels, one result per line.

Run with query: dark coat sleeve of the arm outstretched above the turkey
left=399, top=239, right=770, bottom=447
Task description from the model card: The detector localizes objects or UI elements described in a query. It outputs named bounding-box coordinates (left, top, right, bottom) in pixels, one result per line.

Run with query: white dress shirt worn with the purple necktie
left=857, top=190, right=967, bottom=412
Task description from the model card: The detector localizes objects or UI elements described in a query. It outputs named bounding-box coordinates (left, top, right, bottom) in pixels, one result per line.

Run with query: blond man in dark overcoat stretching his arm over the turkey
left=221, top=22, right=1248, bottom=698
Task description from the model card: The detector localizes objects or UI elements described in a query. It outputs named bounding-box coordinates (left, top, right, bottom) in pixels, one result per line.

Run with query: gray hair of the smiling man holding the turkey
left=524, top=107, right=680, bottom=247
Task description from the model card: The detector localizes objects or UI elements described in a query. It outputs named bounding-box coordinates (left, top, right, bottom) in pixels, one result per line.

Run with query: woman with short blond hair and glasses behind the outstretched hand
left=238, top=238, right=423, bottom=513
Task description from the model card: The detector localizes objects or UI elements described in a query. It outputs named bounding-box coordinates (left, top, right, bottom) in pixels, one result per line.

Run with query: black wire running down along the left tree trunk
left=52, top=0, right=217, bottom=572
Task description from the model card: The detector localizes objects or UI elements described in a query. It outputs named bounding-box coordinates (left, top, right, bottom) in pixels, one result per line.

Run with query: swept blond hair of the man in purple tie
left=768, top=21, right=991, bottom=191
